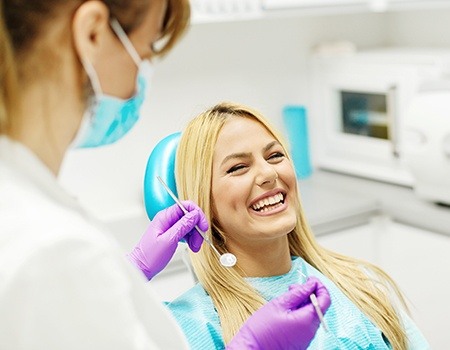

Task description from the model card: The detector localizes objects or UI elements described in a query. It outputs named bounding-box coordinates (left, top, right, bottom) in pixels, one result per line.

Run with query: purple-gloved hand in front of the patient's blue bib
left=226, top=277, right=331, bottom=350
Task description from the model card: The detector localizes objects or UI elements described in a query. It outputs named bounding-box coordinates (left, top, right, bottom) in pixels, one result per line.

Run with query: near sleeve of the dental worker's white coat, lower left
left=0, top=235, right=187, bottom=350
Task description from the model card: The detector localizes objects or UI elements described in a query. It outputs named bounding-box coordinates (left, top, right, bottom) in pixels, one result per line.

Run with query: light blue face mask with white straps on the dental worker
left=73, top=20, right=152, bottom=148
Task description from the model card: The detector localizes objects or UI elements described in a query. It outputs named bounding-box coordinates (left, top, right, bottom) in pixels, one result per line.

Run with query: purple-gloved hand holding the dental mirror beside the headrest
left=128, top=201, right=208, bottom=280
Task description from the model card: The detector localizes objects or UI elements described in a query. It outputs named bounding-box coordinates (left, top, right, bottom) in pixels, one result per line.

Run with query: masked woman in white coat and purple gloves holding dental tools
left=0, top=0, right=330, bottom=350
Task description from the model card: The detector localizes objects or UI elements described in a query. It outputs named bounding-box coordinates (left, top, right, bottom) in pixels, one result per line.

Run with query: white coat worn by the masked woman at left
left=0, top=136, right=188, bottom=350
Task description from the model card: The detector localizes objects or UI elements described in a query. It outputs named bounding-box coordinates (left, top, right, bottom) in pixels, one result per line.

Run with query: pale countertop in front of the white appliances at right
left=299, top=170, right=450, bottom=236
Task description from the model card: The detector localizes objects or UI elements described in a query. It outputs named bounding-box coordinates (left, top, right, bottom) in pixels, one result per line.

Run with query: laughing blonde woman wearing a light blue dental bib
left=168, top=103, right=429, bottom=350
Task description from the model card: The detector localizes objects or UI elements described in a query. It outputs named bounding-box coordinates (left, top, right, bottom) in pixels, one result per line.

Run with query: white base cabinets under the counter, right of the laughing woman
left=317, top=217, right=450, bottom=350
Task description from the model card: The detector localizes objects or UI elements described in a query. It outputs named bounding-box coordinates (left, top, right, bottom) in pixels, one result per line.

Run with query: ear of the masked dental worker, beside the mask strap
left=72, top=0, right=110, bottom=63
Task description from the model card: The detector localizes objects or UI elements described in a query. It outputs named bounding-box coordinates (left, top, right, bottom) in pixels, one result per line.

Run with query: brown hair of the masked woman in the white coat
left=0, top=0, right=190, bottom=134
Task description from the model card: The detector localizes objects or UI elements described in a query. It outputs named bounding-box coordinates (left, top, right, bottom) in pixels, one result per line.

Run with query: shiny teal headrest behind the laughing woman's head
left=144, top=132, right=181, bottom=220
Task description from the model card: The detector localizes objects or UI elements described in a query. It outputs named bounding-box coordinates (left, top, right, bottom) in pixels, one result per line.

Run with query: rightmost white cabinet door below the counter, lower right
left=379, top=223, right=450, bottom=349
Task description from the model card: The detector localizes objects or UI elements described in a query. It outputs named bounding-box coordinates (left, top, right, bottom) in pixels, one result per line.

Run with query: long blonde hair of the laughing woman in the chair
left=176, top=103, right=407, bottom=350
